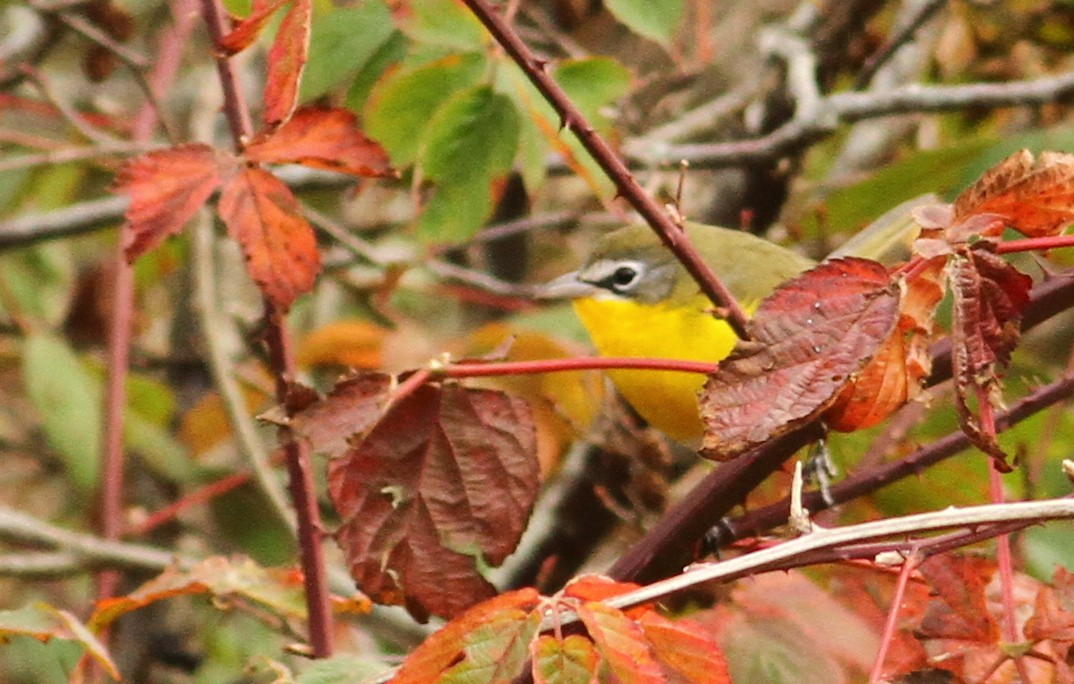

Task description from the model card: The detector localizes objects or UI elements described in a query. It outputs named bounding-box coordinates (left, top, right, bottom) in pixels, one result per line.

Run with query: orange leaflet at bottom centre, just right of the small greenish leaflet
left=576, top=602, right=667, bottom=684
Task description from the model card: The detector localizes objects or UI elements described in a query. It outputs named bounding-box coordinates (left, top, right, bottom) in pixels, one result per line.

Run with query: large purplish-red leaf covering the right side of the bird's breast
left=700, top=259, right=899, bottom=460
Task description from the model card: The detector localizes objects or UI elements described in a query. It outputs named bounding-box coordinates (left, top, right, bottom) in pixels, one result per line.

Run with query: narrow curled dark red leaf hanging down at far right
left=948, top=249, right=1033, bottom=468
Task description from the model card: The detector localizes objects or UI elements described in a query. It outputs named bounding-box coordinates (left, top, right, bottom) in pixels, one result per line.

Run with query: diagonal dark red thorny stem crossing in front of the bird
left=463, top=0, right=749, bottom=339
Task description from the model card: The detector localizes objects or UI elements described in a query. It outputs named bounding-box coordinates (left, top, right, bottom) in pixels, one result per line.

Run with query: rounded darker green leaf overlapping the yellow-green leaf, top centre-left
left=421, top=86, right=520, bottom=184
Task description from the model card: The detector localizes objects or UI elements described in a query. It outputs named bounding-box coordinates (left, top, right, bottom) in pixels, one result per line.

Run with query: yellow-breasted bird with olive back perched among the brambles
left=538, top=199, right=937, bottom=448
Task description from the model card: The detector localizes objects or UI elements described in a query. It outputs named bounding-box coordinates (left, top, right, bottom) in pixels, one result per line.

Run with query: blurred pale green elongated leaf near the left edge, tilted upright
left=23, top=333, right=101, bottom=493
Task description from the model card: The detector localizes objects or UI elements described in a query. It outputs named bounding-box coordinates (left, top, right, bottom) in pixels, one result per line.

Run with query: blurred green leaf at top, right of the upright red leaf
left=300, top=0, right=395, bottom=101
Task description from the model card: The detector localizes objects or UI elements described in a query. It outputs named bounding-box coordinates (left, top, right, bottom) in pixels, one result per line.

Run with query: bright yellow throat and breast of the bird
left=574, top=295, right=738, bottom=445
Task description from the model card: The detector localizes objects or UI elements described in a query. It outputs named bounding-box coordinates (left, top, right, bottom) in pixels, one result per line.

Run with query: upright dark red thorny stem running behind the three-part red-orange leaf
left=202, top=0, right=332, bottom=658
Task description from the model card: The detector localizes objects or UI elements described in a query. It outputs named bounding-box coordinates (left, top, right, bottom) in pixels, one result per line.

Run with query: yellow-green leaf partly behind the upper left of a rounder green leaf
left=365, top=54, right=485, bottom=166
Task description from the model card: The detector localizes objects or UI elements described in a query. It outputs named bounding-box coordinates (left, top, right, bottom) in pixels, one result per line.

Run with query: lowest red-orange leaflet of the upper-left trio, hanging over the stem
left=219, top=168, right=321, bottom=310
